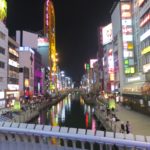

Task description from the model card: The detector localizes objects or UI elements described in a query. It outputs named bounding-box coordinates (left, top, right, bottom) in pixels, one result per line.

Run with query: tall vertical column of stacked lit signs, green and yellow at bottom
left=121, top=1, right=135, bottom=74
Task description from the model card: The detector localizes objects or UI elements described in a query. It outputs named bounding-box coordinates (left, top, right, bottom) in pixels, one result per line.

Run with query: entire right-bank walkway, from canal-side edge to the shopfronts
left=96, top=99, right=150, bottom=136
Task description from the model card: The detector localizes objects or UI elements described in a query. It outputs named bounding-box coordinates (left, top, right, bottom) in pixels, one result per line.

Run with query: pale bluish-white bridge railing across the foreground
left=0, top=122, right=150, bottom=150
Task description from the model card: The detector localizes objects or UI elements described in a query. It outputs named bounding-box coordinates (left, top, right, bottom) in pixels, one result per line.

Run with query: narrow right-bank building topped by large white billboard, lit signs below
left=102, top=23, right=113, bottom=93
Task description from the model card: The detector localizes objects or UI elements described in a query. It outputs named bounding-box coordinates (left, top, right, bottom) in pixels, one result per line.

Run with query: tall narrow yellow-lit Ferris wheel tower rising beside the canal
left=44, top=0, right=57, bottom=91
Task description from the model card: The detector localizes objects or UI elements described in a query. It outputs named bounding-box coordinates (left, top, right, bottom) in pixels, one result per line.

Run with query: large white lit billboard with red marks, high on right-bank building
left=102, top=23, right=112, bottom=45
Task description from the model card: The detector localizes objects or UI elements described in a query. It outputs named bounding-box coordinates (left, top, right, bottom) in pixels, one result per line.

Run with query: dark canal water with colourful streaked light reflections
left=36, top=94, right=96, bottom=131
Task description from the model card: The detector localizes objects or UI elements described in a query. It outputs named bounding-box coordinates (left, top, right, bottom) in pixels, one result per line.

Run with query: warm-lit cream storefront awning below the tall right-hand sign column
left=122, top=82, right=145, bottom=95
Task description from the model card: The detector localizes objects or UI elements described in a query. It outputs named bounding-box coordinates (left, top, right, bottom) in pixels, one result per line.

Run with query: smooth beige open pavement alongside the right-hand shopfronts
left=116, top=104, right=150, bottom=136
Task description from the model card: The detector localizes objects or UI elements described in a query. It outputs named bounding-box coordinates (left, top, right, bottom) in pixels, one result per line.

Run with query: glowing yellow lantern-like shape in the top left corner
left=0, top=0, right=7, bottom=20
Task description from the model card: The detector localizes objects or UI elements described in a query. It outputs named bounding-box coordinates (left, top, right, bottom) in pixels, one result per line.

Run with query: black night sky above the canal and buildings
left=7, top=0, right=114, bottom=82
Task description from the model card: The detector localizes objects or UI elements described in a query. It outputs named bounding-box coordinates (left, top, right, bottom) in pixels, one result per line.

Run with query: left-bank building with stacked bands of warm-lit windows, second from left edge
left=5, top=37, right=20, bottom=107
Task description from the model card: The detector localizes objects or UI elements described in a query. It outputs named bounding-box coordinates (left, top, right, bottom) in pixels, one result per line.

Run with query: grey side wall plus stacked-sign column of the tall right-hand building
left=111, top=0, right=136, bottom=93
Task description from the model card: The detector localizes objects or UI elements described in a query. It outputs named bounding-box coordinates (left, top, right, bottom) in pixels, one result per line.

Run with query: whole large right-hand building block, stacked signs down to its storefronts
left=111, top=0, right=150, bottom=114
